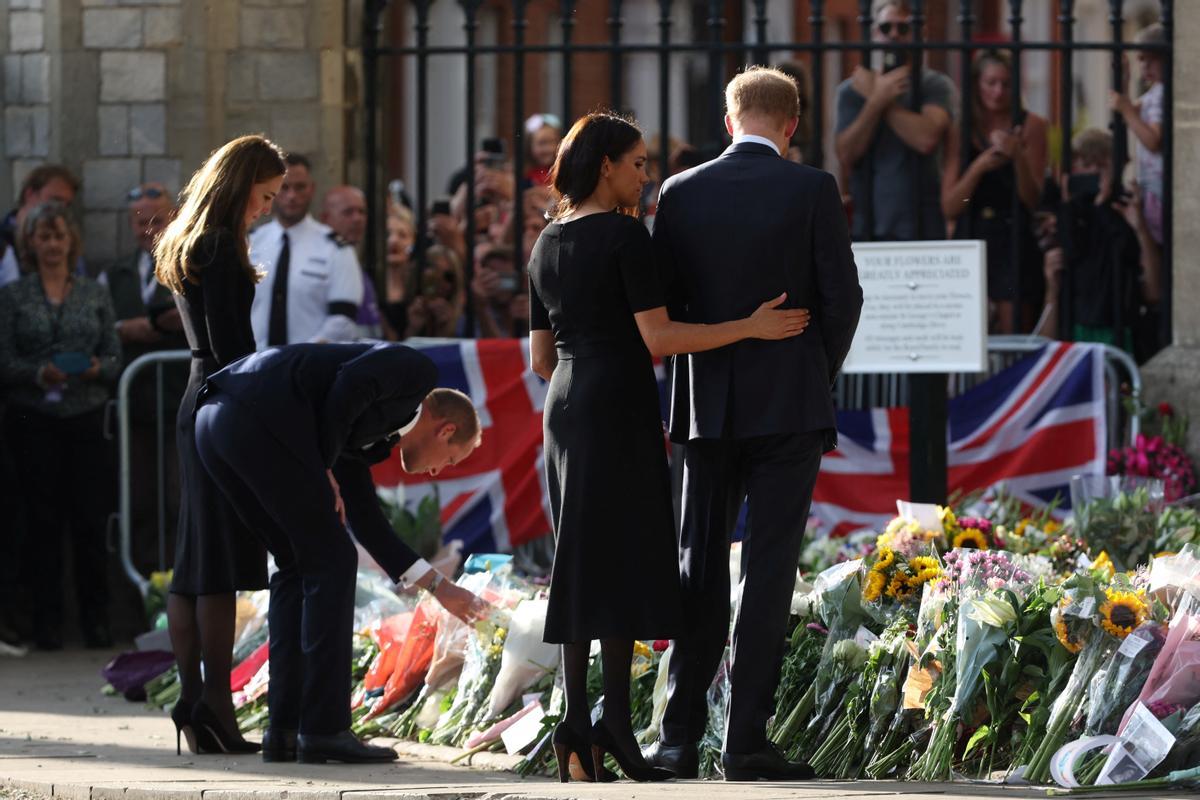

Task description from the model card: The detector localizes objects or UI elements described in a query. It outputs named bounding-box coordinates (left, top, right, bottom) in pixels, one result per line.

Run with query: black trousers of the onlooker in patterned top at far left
left=5, top=405, right=116, bottom=637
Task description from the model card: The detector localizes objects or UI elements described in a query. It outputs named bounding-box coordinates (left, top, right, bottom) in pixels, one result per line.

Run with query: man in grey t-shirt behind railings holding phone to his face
left=836, top=0, right=954, bottom=241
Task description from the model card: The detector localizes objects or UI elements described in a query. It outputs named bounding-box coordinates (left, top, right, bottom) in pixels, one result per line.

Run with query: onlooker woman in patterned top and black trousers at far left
left=0, top=203, right=121, bottom=650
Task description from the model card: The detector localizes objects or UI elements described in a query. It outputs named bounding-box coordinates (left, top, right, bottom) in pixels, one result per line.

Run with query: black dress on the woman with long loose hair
left=170, top=229, right=266, bottom=595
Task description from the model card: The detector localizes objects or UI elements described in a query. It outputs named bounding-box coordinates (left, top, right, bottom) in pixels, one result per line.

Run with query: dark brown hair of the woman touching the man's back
left=549, top=112, right=642, bottom=220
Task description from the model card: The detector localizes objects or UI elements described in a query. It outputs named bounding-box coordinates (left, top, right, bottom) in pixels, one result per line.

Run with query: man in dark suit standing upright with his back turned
left=647, top=67, right=863, bottom=780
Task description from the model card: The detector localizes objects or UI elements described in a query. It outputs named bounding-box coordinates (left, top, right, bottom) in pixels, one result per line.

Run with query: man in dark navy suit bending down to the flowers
left=196, top=344, right=486, bottom=763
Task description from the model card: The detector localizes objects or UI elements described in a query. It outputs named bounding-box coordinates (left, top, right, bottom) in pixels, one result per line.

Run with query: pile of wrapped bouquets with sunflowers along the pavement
left=136, top=455, right=1200, bottom=792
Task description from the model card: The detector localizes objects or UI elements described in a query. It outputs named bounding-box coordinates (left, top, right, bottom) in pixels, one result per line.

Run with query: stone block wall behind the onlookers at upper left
left=0, top=0, right=356, bottom=263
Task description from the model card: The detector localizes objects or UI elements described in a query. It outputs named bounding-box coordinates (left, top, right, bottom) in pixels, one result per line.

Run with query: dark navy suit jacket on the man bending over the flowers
left=208, top=343, right=438, bottom=579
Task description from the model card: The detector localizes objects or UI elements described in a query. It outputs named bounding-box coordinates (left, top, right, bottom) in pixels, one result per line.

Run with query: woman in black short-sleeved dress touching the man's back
left=529, top=113, right=809, bottom=781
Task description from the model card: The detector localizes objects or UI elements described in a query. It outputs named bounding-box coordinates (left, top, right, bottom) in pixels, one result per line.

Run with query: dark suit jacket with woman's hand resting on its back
left=654, top=142, right=863, bottom=449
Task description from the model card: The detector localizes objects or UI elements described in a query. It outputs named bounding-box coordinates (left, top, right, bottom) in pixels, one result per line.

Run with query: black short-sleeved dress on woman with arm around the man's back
left=529, top=213, right=683, bottom=644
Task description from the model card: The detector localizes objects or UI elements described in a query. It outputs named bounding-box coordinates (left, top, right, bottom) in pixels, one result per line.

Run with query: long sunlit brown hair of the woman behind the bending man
left=154, top=136, right=288, bottom=294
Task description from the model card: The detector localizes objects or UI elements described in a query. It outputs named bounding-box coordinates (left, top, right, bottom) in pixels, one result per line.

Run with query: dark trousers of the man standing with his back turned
left=662, top=432, right=824, bottom=753
